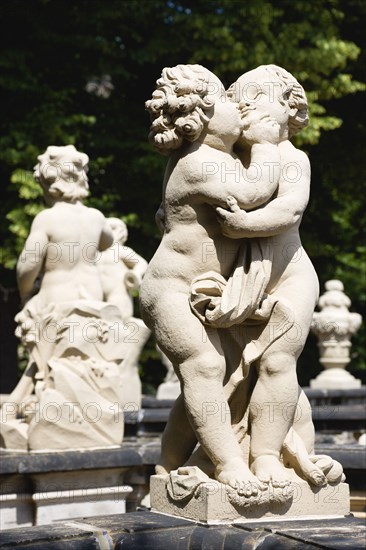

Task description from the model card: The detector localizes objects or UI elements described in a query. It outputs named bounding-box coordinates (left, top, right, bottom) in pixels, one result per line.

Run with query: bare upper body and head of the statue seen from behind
left=17, top=145, right=113, bottom=308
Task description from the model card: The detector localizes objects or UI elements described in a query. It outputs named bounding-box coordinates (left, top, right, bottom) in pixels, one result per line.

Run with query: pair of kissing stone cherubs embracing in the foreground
left=140, top=65, right=342, bottom=512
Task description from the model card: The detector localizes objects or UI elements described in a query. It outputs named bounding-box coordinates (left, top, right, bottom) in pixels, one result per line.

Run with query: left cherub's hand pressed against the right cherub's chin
left=239, top=101, right=280, bottom=145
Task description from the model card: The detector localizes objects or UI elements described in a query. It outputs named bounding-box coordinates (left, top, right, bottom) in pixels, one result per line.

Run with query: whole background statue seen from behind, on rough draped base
left=1, top=145, right=128, bottom=450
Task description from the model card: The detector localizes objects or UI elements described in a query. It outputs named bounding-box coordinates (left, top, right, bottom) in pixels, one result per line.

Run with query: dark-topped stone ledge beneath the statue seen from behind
left=0, top=447, right=148, bottom=528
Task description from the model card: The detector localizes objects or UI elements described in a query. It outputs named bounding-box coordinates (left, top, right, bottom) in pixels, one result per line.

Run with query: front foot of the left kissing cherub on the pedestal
left=216, top=459, right=265, bottom=498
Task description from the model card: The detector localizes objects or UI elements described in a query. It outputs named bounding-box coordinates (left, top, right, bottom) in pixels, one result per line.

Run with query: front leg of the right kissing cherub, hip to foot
left=250, top=278, right=317, bottom=487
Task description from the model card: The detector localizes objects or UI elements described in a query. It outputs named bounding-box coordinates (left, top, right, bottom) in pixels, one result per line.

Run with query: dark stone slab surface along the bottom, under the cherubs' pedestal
left=0, top=511, right=366, bottom=550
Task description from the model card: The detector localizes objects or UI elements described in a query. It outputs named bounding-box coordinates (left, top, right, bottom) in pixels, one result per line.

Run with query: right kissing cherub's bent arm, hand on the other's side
left=216, top=151, right=310, bottom=239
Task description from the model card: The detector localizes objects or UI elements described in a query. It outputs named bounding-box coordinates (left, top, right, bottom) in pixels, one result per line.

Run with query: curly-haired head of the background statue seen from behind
left=34, top=145, right=89, bottom=204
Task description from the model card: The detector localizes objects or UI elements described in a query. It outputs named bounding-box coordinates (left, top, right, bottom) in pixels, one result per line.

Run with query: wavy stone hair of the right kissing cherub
left=227, top=65, right=309, bottom=138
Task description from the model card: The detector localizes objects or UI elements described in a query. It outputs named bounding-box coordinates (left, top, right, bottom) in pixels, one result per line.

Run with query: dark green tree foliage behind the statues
left=0, top=0, right=366, bottom=386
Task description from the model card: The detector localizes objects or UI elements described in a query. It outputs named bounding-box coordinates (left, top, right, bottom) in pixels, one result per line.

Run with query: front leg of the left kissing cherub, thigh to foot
left=152, top=287, right=260, bottom=496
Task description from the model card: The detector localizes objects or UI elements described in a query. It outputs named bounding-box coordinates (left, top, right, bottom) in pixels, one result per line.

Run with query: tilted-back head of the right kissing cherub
left=227, top=65, right=309, bottom=139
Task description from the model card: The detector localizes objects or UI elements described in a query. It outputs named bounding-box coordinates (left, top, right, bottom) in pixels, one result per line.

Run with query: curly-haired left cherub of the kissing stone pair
left=140, top=65, right=280, bottom=496
